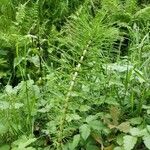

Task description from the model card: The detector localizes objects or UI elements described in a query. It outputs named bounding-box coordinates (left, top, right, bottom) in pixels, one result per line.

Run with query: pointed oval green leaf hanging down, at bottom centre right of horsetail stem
left=79, top=124, right=91, bottom=140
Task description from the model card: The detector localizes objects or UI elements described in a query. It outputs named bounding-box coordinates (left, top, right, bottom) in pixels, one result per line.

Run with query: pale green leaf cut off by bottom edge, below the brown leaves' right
left=123, top=135, right=137, bottom=150
